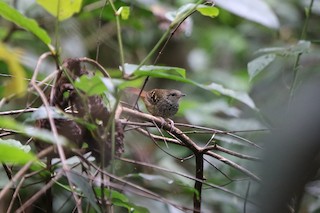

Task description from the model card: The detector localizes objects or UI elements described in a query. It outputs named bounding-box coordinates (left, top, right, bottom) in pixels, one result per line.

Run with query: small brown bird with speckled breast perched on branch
left=127, top=88, right=185, bottom=118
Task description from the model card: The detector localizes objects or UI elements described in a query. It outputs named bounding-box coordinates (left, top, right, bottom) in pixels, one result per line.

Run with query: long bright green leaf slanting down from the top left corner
left=0, top=1, right=53, bottom=46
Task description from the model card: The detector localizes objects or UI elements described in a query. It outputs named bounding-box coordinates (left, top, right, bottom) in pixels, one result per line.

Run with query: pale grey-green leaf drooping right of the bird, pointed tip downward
left=248, top=54, right=276, bottom=81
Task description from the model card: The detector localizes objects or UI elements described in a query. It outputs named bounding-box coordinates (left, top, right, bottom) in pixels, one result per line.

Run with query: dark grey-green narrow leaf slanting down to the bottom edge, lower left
left=67, top=171, right=101, bottom=212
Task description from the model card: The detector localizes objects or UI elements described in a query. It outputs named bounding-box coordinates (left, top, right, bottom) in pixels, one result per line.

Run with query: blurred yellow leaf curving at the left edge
left=0, top=43, right=27, bottom=97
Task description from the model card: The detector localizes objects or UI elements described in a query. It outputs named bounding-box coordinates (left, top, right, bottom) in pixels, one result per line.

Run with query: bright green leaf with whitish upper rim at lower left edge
left=0, top=139, right=37, bottom=165
